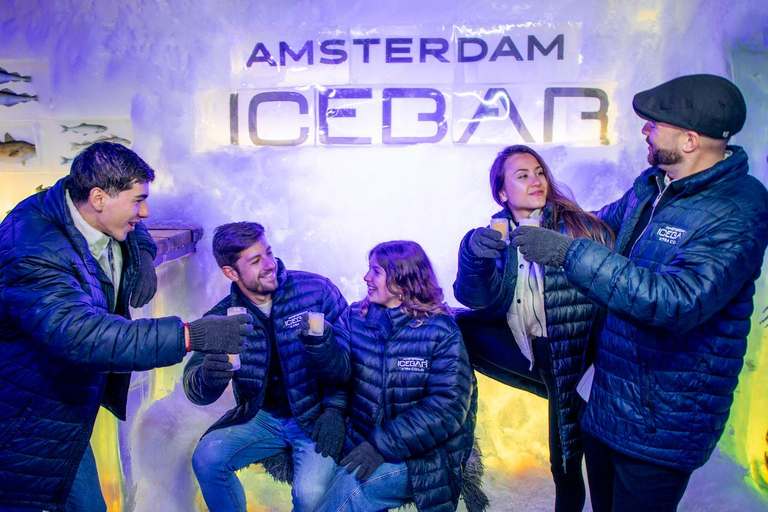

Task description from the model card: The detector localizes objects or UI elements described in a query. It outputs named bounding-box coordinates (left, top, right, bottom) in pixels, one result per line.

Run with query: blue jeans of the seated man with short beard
left=192, top=411, right=336, bottom=512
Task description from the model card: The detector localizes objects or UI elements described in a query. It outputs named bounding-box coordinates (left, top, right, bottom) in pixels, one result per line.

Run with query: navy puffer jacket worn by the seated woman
left=304, top=303, right=477, bottom=512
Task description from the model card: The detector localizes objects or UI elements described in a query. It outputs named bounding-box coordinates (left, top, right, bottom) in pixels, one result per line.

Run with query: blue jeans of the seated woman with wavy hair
left=316, top=462, right=413, bottom=512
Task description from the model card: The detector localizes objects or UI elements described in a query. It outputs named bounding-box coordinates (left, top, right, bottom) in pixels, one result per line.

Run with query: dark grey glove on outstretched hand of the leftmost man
left=189, top=315, right=253, bottom=354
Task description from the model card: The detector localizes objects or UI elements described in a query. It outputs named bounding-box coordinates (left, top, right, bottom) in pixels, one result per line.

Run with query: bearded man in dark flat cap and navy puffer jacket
left=512, top=75, right=768, bottom=512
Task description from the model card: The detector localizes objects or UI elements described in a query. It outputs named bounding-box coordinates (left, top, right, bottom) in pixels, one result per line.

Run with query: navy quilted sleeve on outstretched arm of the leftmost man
left=0, top=246, right=186, bottom=373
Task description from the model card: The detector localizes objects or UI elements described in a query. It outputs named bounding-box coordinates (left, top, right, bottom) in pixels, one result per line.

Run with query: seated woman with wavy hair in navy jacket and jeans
left=301, top=241, right=477, bottom=512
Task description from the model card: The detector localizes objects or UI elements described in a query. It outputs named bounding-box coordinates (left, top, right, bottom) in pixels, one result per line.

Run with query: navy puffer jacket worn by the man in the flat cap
left=564, top=146, right=768, bottom=471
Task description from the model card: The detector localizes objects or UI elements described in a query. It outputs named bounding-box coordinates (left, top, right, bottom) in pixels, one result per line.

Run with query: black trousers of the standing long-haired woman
left=456, top=313, right=586, bottom=512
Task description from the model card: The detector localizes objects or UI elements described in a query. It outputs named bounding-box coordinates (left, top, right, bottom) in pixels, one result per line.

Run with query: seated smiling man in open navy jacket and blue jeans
left=184, top=222, right=347, bottom=512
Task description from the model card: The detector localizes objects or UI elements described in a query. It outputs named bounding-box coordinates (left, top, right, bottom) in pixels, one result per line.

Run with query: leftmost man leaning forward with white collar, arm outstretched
left=0, top=142, right=253, bottom=512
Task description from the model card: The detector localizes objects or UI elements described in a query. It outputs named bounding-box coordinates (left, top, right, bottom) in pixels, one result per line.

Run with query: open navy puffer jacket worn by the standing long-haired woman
left=453, top=207, right=596, bottom=460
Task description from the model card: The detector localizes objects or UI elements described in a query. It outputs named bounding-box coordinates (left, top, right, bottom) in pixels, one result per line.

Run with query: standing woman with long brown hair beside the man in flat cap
left=453, top=145, right=613, bottom=512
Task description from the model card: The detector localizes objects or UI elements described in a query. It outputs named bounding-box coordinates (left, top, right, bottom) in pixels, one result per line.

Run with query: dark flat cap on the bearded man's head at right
left=632, top=75, right=747, bottom=139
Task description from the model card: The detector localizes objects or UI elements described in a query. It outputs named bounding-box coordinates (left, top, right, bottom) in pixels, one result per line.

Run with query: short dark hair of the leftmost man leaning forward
left=67, top=142, right=155, bottom=204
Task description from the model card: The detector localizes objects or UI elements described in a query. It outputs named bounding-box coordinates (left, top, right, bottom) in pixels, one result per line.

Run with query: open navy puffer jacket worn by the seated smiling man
left=184, top=260, right=347, bottom=436
